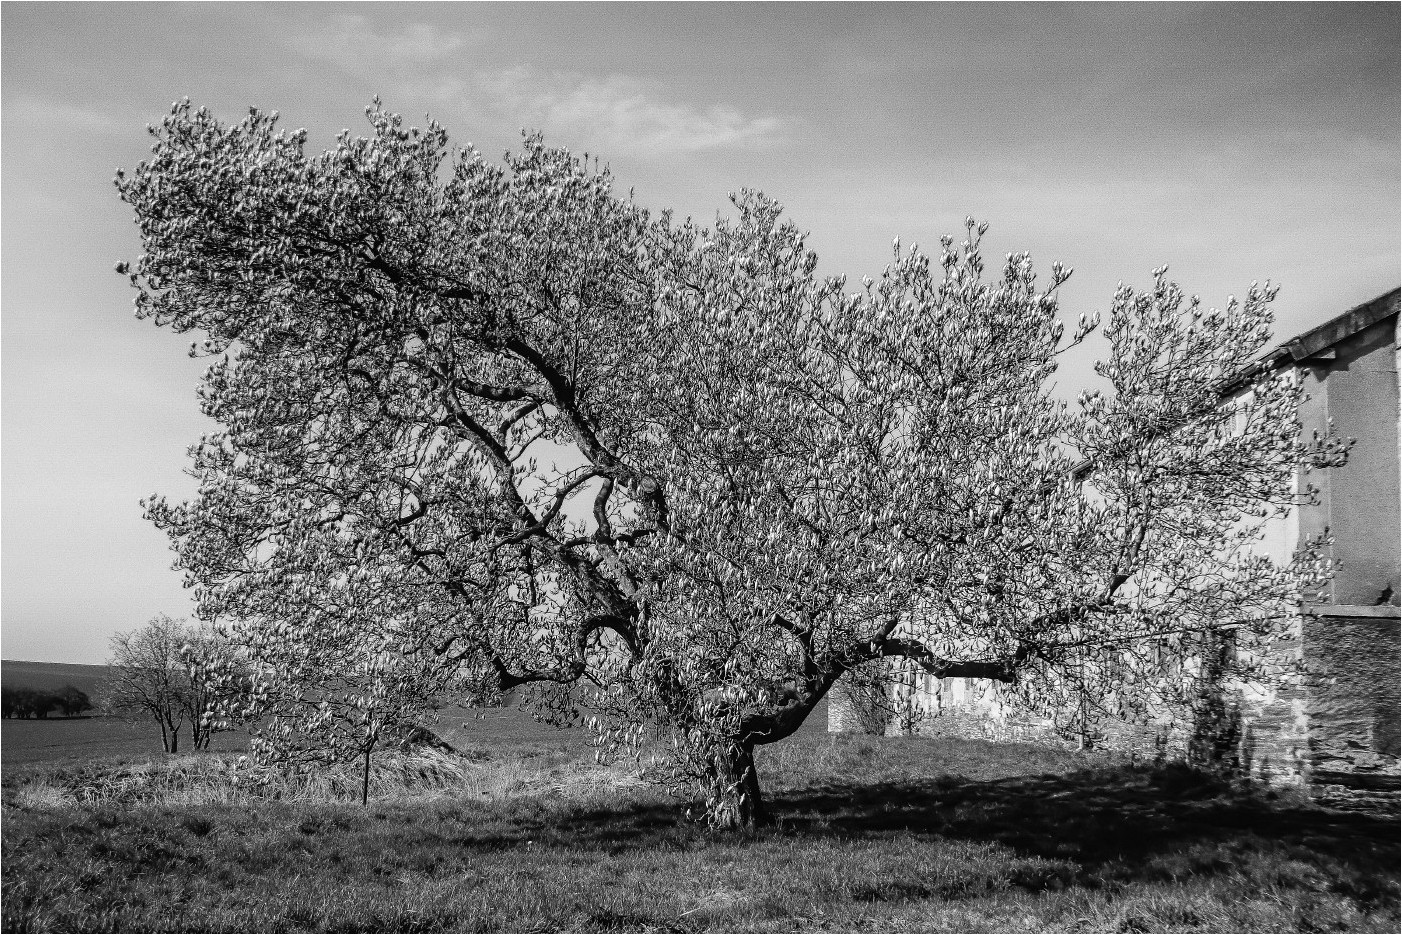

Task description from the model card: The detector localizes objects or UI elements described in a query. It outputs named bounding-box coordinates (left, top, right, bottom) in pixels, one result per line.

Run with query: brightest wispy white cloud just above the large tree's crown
left=435, top=66, right=781, bottom=156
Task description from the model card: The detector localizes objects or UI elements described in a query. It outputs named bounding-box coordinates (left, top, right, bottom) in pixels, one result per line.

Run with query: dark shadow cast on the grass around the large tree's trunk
left=464, top=767, right=1402, bottom=904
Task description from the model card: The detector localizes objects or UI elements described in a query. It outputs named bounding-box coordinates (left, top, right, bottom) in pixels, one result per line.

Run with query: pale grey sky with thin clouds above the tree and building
left=0, top=3, right=1402, bottom=663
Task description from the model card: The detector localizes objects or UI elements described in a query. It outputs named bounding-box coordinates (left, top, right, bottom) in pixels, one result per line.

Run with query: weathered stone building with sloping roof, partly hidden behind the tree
left=829, top=290, right=1402, bottom=798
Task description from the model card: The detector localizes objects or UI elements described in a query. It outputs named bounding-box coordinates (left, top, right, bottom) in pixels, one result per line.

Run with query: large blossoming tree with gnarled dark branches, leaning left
left=118, top=104, right=1323, bottom=824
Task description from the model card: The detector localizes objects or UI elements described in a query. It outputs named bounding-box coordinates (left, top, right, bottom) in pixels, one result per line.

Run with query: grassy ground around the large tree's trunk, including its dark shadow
left=3, top=732, right=1399, bottom=932
